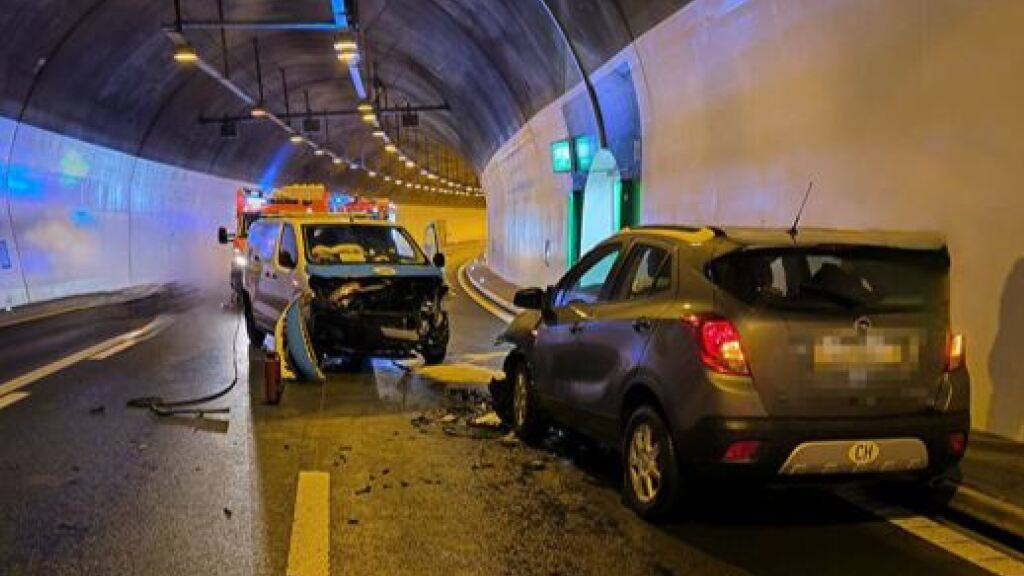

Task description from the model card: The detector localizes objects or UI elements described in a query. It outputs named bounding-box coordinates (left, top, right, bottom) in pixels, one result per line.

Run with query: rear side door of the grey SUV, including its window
left=566, top=240, right=675, bottom=439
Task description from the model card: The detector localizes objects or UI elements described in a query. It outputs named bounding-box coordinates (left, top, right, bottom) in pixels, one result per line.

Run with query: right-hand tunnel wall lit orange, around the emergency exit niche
left=483, top=0, right=1024, bottom=439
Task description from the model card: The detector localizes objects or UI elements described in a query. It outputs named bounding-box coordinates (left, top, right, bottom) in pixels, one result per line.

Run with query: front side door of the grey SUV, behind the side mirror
left=534, top=242, right=624, bottom=424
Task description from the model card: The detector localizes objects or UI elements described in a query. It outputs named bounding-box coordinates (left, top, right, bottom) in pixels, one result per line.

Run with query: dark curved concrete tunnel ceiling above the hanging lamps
left=0, top=0, right=686, bottom=202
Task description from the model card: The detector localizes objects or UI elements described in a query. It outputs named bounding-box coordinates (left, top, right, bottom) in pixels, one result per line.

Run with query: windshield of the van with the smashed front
left=302, top=223, right=427, bottom=264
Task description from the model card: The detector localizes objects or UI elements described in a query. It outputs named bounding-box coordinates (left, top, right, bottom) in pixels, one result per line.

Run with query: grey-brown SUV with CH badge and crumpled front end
left=492, top=227, right=971, bottom=518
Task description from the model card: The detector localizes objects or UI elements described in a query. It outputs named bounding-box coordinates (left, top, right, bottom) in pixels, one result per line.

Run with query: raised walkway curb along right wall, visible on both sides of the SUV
left=460, top=258, right=1024, bottom=540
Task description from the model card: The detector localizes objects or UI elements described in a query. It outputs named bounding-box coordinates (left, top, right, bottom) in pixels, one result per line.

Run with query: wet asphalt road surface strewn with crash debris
left=0, top=246, right=1022, bottom=576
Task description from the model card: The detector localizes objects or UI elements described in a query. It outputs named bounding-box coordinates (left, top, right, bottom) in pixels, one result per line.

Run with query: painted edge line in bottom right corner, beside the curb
left=839, top=488, right=1024, bottom=576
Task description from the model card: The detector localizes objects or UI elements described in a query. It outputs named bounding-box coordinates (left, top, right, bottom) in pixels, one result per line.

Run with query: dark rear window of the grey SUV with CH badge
left=707, top=246, right=949, bottom=312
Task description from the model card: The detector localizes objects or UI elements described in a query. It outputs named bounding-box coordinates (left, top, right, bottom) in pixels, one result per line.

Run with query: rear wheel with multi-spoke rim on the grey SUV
left=622, top=405, right=680, bottom=521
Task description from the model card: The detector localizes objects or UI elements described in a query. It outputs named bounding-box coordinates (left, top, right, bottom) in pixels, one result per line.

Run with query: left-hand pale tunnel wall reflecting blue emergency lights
left=0, top=113, right=242, bottom=307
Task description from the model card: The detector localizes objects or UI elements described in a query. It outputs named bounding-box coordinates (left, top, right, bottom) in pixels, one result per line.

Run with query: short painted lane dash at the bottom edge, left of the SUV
left=287, top=471, right=331, bottom=576
